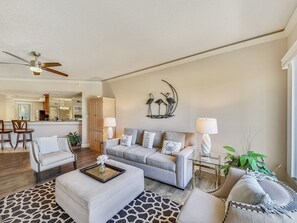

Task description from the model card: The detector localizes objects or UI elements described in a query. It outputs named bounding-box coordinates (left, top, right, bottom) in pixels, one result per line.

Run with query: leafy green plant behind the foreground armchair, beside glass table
left=221, top=146, right=273, bottom=176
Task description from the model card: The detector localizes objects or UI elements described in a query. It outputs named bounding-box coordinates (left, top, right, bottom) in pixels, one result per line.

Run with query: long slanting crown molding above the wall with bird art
left=102, top=29, right=287, bottom=83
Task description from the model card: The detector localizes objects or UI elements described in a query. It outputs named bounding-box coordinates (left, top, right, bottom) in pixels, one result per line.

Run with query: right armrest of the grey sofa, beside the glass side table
left=175, top=146, right=194, bottom=189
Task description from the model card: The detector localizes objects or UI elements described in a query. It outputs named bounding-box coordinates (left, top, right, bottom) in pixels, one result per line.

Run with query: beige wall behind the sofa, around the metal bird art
left=103, top=39, right=287, bottom=178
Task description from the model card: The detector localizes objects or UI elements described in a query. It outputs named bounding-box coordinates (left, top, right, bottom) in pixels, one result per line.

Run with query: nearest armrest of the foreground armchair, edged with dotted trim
left=224, top=201, right=296, bottom=223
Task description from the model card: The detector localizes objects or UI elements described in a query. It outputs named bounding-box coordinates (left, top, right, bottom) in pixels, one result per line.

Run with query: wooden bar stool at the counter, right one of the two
left=11, top=120, right=34, bottom=149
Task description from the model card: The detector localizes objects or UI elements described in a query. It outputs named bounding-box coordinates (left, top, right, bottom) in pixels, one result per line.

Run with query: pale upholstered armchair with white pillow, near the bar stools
left=29, top=136, right=77, bottom=182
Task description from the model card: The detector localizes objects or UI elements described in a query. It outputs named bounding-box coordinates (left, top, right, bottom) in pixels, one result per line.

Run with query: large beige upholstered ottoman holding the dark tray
left=56, top=160, right=144, bottom=223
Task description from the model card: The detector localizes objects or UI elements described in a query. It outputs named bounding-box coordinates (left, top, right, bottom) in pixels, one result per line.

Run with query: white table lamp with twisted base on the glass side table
left=196, top=118, right=218, bottom=156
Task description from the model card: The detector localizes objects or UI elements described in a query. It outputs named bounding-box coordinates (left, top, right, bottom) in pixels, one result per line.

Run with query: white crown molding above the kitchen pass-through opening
left=0, top=77, right=102, bottom=84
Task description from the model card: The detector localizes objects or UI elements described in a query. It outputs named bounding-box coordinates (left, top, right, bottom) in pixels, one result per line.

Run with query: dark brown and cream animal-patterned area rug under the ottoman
left=0, top=181, right=181, bottom=223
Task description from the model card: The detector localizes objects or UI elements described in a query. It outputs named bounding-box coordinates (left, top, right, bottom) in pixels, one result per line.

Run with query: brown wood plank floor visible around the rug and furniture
left=0, top=149, right=215, bottom=204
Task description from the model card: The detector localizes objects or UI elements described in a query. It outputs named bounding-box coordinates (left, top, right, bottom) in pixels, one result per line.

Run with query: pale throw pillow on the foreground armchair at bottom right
left=226, top=174, right=269, bottom=210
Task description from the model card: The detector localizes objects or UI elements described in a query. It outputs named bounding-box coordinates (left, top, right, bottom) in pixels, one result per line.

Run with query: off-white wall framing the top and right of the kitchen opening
left=0, top=78, right=102, bottom=146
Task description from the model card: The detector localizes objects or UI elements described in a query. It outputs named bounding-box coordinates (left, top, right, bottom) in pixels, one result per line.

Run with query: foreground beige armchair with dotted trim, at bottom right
left=177, top=168, right=297, bottom=223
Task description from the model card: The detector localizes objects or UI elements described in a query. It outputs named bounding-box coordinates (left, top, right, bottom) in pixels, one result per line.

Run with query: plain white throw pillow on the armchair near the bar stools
left=35, top=135, right=60, bottom=155
